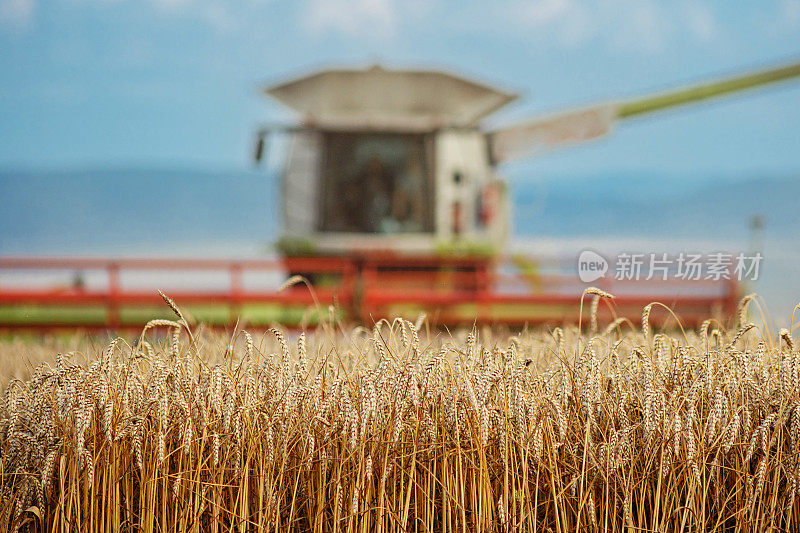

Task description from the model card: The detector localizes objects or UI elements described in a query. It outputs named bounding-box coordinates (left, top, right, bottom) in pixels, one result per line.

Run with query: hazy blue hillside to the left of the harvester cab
left=0, top=169, right=276, bottom=253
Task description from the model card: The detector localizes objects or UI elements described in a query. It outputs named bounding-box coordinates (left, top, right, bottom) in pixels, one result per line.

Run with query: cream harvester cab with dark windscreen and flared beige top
left=256, top=65, right=516, bottom=254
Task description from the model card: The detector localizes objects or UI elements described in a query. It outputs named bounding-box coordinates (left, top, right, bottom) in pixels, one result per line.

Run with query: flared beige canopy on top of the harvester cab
left=264, top=65, right=518, bottom=131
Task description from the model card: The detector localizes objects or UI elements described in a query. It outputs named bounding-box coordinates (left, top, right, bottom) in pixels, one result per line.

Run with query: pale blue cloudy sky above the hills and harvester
left=0, top=0, right=800, bottom=179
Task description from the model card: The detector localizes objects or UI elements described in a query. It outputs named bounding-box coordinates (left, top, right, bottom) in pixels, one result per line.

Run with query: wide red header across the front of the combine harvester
left=0, top=254, right=739, bottom=329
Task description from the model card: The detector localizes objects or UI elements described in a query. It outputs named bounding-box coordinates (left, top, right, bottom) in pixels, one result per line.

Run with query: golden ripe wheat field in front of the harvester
left=0, top=289, right=800, bottom=533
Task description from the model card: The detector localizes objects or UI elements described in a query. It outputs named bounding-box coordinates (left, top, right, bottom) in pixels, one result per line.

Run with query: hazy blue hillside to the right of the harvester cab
left=514, top=171, right=800, bottom=240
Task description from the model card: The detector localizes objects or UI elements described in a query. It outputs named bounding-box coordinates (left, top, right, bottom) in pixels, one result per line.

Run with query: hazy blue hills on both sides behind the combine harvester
left=0, top=169, right=800, bottom=253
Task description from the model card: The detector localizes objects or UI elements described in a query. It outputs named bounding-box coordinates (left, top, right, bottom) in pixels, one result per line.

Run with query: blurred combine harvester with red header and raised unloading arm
left=0, top=58, right=800, bottom=329
